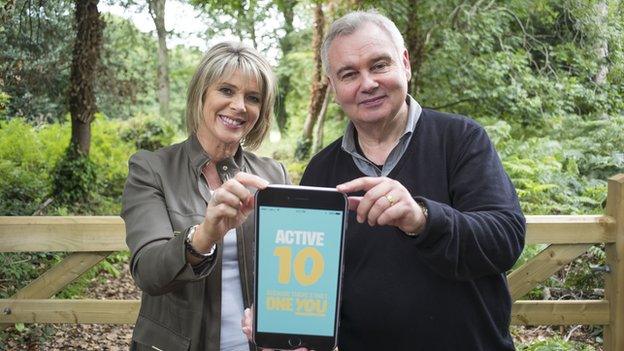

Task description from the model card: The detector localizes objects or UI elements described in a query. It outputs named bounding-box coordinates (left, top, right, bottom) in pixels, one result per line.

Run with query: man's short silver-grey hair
left=321, top=9, right=405, bottom=74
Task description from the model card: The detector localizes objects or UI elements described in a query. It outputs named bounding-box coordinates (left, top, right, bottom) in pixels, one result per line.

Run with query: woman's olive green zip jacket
left=121, top=135, right=289, bottom=351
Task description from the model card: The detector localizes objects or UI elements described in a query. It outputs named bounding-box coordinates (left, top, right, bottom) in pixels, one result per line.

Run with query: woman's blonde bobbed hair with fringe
left=186, top=42, right=277, bottom=149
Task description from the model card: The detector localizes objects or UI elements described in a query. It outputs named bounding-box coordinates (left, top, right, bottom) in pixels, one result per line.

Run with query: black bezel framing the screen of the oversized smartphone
left=252, top=185, right=348, bottom=351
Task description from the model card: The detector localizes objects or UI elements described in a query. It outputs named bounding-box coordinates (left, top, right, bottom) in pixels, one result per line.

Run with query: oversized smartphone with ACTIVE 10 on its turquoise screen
left=253, top=186, right=347, bottom=351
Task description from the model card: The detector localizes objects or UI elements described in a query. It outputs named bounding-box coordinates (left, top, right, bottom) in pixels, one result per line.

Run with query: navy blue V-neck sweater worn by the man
left=301, top=109, right=525, bottom=351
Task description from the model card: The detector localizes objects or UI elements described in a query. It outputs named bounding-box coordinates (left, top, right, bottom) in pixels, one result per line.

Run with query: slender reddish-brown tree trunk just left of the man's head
left=295, top=1, right=327, bottom=160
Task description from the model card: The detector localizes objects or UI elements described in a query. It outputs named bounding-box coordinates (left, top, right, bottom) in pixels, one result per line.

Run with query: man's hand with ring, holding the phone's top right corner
left=336, top=177, right=426, bottom=233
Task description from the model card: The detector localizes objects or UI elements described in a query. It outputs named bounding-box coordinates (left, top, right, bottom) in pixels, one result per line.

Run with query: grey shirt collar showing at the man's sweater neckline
left=342, top=95, right=422, bottom=177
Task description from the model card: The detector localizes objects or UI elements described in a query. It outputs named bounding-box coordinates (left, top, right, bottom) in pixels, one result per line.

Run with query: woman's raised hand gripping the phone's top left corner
left=193, top=172, right=269, bottom=252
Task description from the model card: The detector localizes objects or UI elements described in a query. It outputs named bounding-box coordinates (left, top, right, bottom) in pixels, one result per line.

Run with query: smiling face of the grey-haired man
left=328, top=23, right=411, bottom=124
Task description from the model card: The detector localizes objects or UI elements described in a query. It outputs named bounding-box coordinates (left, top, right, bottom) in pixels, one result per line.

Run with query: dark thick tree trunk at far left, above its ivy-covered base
left=69, top=0, right=103, bottom=155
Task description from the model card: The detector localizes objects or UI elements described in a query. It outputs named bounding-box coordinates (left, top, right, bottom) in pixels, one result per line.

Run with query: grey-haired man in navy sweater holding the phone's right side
left=301, top=12, right=525, bottom=351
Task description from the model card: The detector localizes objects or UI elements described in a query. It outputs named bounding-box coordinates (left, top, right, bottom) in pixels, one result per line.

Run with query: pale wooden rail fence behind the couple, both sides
left=0, top=174, right=624, bottom=351
